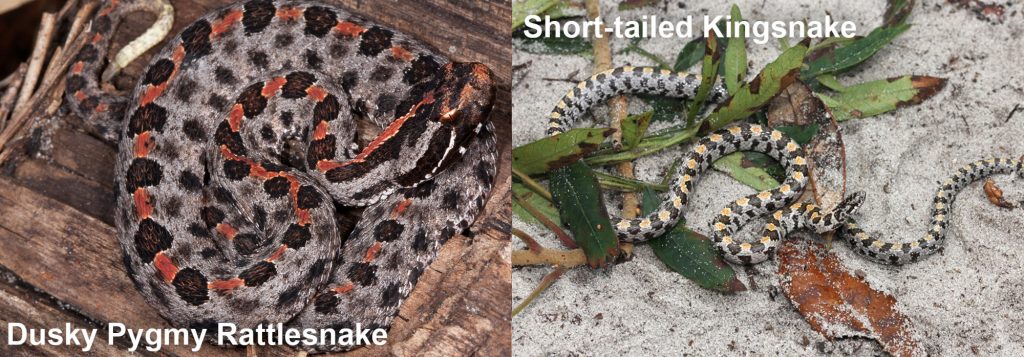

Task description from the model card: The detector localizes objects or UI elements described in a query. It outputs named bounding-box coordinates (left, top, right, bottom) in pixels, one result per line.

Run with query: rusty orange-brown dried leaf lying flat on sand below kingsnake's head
left=778, top=240, right=921, bottom=356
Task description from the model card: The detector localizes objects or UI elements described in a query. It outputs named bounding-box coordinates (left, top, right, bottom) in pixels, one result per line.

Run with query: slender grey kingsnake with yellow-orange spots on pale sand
left=548, top=66, right=1024, bottom=264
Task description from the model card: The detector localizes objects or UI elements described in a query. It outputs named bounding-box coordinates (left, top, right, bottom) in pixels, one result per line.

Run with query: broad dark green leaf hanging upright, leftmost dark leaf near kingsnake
left=549, top=162, right=618, bottom=267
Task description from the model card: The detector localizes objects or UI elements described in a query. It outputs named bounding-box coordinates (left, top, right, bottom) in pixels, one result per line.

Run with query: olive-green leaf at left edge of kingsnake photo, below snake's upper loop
left=512, top=128, right=613, bottom=176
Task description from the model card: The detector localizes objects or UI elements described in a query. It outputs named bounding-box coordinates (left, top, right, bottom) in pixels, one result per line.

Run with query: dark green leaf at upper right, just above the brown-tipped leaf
left=800, top=24, right=910, bottom=80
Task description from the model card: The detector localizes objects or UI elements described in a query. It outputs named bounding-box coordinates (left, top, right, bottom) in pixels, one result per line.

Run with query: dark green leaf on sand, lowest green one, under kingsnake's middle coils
left=641, top=189, right=746, bottom=294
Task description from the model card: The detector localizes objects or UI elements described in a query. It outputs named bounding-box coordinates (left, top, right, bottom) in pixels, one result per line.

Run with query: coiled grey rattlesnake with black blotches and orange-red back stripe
left=67, top=0, right=497, bottom=351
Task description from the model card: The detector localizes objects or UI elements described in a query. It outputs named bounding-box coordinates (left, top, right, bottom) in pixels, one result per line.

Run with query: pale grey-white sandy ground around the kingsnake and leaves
left=512, top=0, right=1024, bottom=356
